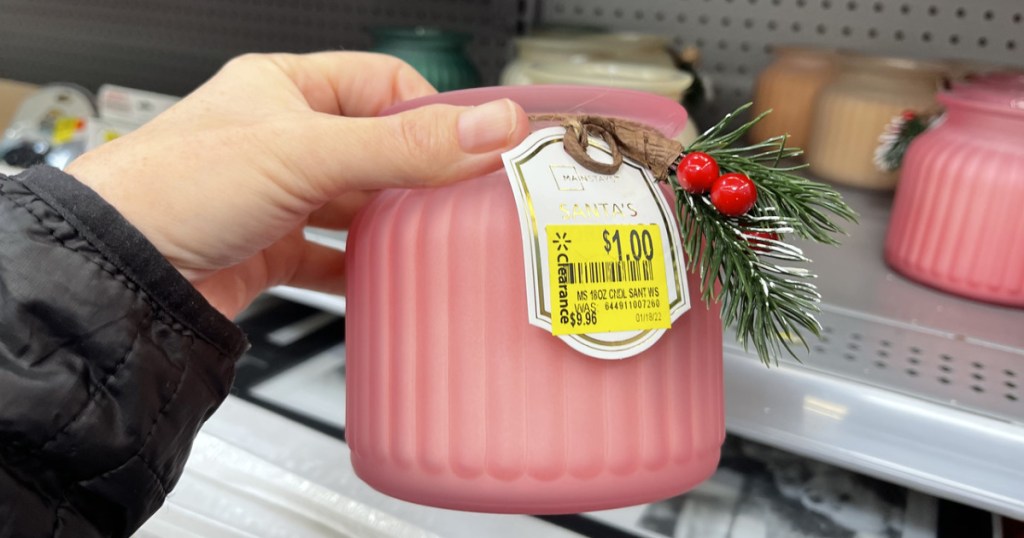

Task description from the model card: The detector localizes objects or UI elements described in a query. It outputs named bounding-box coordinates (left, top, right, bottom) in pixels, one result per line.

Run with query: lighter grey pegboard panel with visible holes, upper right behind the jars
left=537, top=0, right=1024, bottom=122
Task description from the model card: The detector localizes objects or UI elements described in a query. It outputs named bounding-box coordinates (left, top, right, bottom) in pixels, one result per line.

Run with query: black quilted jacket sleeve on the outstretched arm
left=0, top=167, right=247, bottom=538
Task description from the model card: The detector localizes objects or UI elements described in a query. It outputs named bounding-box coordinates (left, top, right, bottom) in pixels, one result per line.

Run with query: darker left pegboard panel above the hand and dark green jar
left=0, top=0, right=529, bottom=94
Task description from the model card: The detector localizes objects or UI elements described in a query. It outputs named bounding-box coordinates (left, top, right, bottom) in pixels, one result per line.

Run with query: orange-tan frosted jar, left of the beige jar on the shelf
left=750, top=46, right=840, bottom=148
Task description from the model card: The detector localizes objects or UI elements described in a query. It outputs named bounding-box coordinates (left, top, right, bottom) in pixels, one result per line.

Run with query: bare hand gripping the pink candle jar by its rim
left=68, top=52, right=528, bottom=318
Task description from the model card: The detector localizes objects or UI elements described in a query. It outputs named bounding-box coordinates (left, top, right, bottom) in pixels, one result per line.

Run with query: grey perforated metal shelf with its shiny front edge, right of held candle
left=725, top=183, right=1024, bottom=519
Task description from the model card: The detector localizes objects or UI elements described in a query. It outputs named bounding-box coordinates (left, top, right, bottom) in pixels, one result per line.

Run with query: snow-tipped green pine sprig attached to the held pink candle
left=669, top=105, right=857, bottom=365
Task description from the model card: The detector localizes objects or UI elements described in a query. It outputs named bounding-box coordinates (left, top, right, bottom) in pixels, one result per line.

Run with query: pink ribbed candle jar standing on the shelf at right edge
left=886, top=74, right=1024, bottom=306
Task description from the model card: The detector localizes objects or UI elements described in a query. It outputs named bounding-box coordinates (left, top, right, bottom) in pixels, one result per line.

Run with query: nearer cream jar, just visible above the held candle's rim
left=523, top=61, right=698, bottom=146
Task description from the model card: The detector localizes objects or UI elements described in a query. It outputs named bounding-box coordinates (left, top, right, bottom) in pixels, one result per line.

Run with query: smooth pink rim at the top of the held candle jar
left=382, top=85, right=686, bottom=137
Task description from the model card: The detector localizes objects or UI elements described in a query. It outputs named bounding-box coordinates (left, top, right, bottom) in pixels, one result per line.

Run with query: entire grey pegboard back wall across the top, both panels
left=0, top=0, right=1024, bottom=124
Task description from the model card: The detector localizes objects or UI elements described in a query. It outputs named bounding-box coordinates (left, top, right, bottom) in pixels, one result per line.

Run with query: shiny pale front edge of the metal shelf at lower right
left=724, top=346, right=1024, bottom=519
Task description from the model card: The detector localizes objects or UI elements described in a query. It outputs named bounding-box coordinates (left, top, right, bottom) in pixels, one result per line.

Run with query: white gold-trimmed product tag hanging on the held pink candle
left=502, top=127, right=690, bottom=359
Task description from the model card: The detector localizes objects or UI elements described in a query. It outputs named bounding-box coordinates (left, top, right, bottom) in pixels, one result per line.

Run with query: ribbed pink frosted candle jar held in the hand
left=346, top=86, right=725, bottom=513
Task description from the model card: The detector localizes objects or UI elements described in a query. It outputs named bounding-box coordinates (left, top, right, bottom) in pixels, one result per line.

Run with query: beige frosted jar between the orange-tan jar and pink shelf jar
left=807, top=55, right=946, bottom=190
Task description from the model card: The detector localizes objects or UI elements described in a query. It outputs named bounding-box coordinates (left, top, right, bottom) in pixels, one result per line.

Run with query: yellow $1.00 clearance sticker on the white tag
left=545, top=224, right=672, bottom=335
